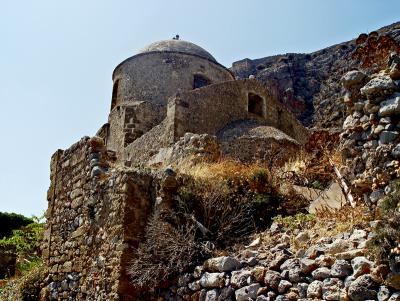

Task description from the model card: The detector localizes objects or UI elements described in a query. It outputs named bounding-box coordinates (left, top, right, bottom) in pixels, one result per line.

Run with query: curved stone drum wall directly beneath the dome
left=112, top=52, right=234, bottom=107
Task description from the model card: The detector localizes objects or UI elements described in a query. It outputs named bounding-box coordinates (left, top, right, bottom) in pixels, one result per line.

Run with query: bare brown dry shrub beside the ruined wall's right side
left=128, top=212, right=200, bottom=288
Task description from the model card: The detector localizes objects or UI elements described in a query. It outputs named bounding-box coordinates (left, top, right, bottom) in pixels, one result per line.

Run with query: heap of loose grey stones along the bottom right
left=159, top=229, right=400, bottom=301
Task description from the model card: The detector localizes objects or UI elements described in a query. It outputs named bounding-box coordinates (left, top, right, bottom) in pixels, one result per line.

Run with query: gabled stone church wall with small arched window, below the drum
left=167, top=80, right=308, bottom=144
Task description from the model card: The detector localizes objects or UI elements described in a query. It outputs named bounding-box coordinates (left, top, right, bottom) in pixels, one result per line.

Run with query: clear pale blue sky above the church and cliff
left=0, top=0, right=400, bottom=216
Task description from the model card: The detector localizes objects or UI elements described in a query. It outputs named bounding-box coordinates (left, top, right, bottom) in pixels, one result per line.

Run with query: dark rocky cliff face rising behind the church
left=231, top=22, right=400, bottom=128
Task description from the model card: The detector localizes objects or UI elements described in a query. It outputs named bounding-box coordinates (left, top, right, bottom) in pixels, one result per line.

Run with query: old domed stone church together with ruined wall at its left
left=42, top=39, right=308, bottom=300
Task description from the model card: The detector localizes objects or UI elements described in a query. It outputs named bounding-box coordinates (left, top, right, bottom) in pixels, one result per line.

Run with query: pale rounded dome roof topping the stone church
left=139, top=40, right=217, bottom=63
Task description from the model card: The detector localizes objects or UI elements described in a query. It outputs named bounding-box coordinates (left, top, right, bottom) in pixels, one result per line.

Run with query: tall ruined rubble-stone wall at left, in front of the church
left=42, top=137, right=154, bottom=300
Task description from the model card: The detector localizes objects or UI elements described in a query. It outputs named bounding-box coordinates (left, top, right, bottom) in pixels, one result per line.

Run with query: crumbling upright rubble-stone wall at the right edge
left=341, top=53, right=400, bottom=207
